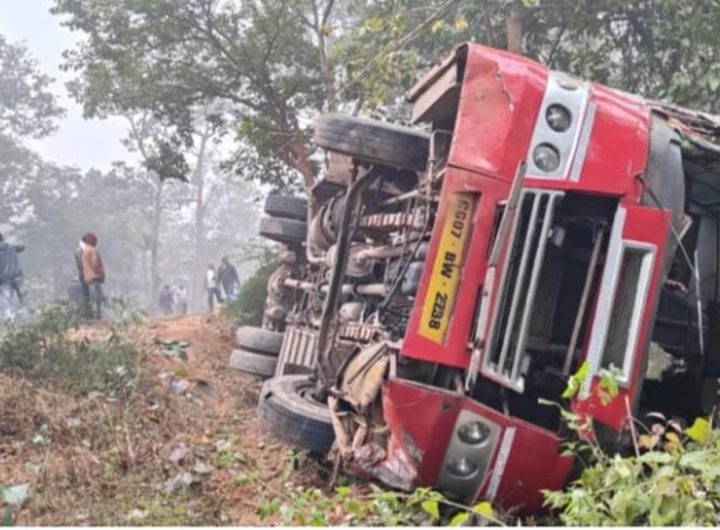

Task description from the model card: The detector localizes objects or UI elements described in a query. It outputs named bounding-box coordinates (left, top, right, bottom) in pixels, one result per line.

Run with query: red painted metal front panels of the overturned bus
left=383, top=44, right=670, bottom=511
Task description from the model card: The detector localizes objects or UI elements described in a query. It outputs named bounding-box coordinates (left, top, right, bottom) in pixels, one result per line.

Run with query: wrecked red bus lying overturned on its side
left=232, top=44, right=720, bottom=512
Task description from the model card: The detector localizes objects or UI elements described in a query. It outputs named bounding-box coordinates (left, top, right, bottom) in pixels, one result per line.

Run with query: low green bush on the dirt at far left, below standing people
left=0, top=306, right=137, bottom=394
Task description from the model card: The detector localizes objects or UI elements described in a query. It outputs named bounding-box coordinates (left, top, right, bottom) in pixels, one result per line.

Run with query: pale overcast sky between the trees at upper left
left=0, top=0, right=134, bottom=169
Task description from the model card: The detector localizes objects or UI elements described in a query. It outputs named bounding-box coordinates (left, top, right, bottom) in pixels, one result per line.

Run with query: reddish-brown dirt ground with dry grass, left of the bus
left=0, top=315, right=326, bottom=526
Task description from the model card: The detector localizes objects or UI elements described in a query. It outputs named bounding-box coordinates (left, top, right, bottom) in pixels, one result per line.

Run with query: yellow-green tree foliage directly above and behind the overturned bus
left=337, top=0, right=720, bottom=116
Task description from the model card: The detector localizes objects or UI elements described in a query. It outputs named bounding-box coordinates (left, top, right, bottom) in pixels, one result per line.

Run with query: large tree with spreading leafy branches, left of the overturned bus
left=53, top=0, right=348, bottom=187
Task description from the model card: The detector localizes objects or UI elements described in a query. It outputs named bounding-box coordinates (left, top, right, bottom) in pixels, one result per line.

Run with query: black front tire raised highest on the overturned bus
left=315, top=114, right=430, bottom=171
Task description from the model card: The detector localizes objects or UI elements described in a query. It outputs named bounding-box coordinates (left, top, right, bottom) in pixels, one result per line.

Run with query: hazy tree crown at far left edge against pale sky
left=0, top=35, right=64, bottom=138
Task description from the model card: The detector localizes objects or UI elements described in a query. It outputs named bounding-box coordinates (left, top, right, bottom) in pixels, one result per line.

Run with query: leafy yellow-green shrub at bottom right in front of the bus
left=543, top=366, right=720, bottom=526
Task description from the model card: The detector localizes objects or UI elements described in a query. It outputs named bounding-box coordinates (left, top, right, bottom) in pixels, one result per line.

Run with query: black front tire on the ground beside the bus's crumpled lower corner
left=258, top=375, right=335, bottom=454
